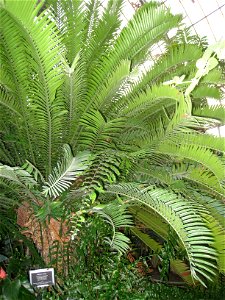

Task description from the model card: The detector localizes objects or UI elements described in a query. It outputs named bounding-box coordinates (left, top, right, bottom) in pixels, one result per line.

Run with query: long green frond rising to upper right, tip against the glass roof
left=82, top=3, right=180, bottom=119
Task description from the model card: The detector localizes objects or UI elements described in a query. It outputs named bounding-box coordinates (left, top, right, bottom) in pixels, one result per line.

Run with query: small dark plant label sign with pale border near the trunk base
left=29, top=268, right=55, bottom=287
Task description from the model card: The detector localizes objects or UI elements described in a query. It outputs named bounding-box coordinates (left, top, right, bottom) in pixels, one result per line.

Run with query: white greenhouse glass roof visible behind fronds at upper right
left=102, top=0, right=225, bottom=137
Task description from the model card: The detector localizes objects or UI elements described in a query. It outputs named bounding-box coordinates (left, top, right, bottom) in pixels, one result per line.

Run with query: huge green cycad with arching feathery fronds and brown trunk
left=0, top=0, right=225, bottom=284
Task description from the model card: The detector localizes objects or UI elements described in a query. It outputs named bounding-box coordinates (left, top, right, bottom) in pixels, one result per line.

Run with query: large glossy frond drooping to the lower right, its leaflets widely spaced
left=108, top=183, right=218, bottom=285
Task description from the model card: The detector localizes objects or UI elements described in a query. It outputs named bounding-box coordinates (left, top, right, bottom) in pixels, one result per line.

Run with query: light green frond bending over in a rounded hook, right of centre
left=111, top=85, right=189, bottom=152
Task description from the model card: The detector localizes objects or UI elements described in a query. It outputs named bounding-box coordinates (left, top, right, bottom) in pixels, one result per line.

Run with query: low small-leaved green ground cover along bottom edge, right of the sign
left=39, top=253, right=224, bottom=300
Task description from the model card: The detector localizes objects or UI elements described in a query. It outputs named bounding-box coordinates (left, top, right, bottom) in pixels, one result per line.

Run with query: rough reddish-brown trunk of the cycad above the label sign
left=17, top=201, right=70, bottom=273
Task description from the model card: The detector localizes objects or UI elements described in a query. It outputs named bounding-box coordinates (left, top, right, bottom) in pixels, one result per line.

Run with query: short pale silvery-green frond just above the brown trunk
left=42, top=145, right=90, bottom=198
